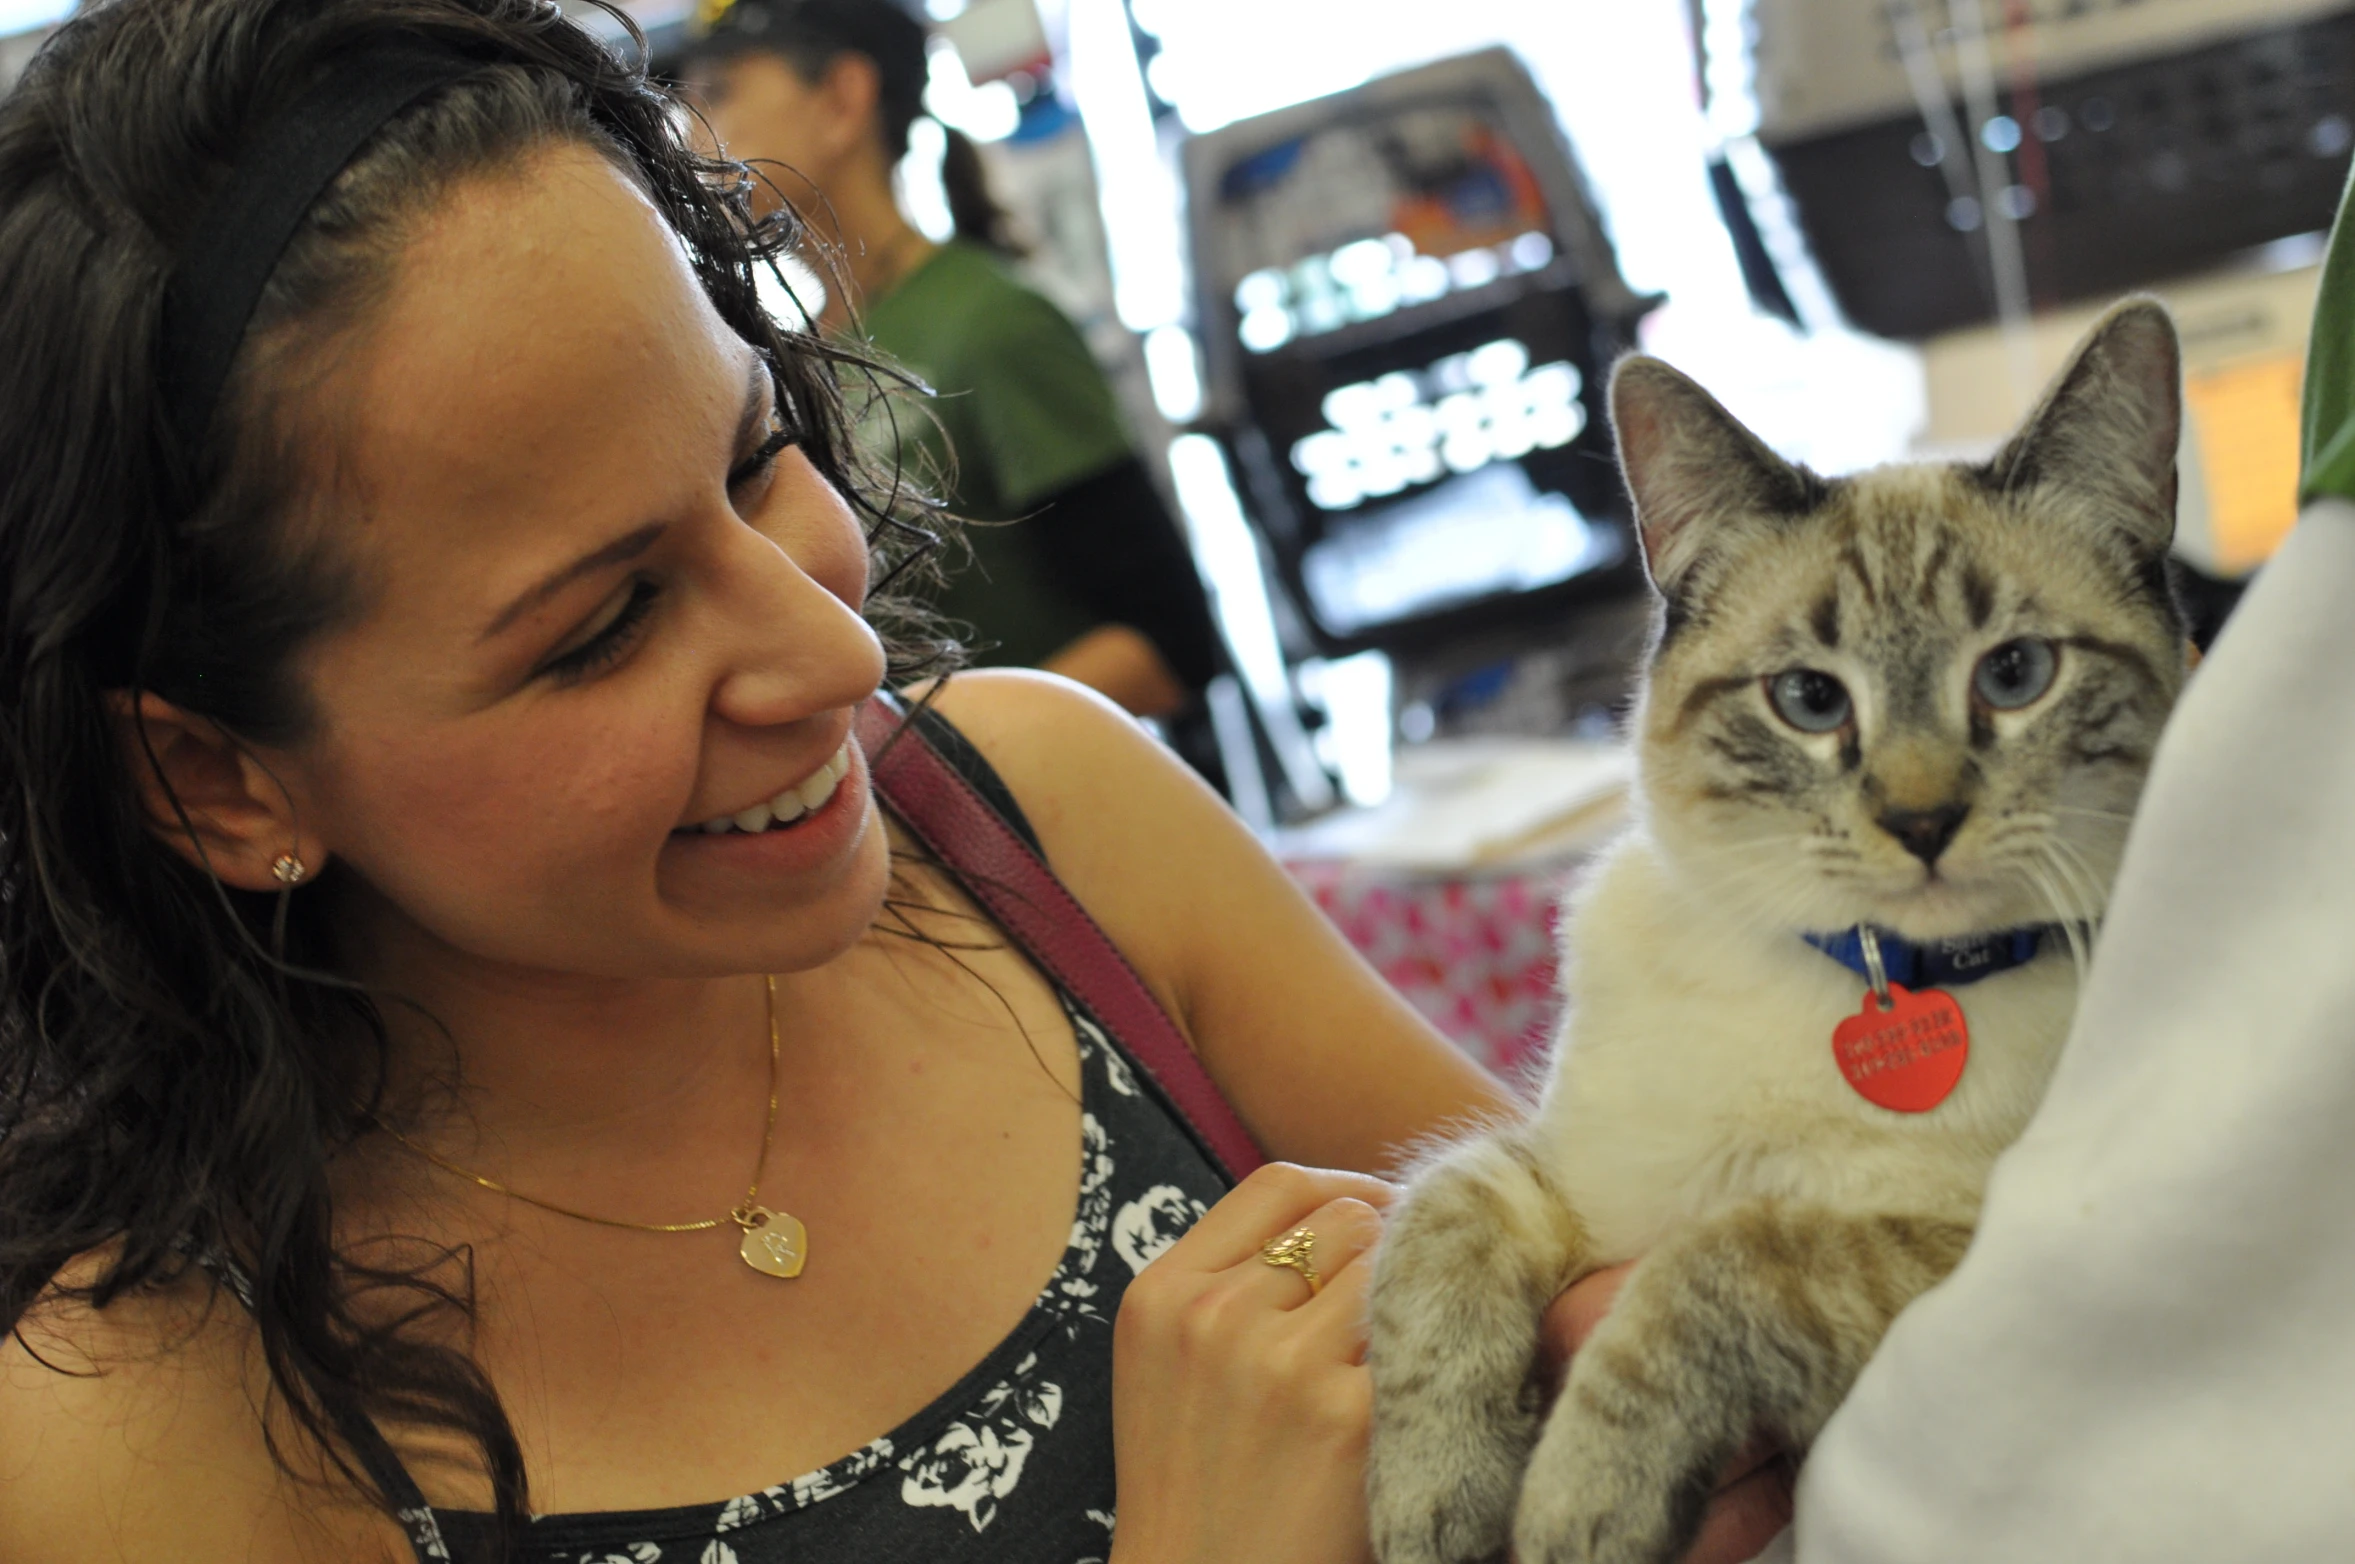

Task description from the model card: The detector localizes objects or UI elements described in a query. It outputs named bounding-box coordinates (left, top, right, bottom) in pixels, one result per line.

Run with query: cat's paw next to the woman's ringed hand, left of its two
left=1366, top=1416, right=1535, bottom=1564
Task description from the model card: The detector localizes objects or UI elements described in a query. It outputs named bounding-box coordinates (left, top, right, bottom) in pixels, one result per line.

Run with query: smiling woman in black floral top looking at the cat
left=0, top=0, right=1500, bottom=1564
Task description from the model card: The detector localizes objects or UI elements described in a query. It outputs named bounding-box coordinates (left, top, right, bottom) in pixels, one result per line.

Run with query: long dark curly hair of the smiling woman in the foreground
left=0, top=0, right=954, bottom=1540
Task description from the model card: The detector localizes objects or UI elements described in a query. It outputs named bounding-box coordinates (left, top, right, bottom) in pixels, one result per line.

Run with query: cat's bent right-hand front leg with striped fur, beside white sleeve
left=1514, top=1201, right=1971, bottom=1564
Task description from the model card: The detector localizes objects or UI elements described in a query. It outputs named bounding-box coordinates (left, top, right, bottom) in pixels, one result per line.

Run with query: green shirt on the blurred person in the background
left=864, top=240, right=1130, bottom=664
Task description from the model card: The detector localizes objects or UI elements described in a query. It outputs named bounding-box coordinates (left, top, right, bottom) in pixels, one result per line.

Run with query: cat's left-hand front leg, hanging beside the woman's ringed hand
left=1366, top=1128, right=1585, bottom=1564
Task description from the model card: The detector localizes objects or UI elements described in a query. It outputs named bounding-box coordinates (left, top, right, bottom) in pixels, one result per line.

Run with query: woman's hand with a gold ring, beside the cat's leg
left=1112, top=1164, right=1392, bottom=1564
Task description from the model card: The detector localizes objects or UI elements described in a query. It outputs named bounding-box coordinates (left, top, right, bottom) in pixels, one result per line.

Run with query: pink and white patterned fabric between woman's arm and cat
left=1286, top=860, right=1578, bottom=1079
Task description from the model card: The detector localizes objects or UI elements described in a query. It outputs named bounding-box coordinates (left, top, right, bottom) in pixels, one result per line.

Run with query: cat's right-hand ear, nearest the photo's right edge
left=1985, top=299, right=2183, bottom=554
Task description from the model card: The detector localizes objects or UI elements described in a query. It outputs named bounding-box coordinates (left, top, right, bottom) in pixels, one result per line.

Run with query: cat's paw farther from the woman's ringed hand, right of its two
left=1512, top=1397, right=1710, bottom=1564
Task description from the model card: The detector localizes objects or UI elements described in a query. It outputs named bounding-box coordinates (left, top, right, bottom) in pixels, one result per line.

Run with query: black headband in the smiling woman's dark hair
left=160, top=33, right=483, bottom=452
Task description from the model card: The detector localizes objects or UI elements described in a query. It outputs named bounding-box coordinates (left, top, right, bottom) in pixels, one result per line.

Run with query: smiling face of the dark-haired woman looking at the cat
left=271, top=146, right=888, bottom=978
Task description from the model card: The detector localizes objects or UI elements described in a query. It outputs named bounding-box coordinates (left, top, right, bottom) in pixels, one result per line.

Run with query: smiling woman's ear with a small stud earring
left=113, top=692, right=325, bottom=890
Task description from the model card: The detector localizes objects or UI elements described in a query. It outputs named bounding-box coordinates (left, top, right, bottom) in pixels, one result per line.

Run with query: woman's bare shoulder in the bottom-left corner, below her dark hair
left=0, top=1263, right=410, bottom=1564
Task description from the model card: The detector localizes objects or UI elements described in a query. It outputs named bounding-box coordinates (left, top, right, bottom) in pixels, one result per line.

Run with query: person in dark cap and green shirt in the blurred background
left=668, top=0, right=1218, bottom=716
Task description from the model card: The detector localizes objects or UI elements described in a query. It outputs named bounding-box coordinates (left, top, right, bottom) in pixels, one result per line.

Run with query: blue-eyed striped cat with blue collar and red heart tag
left=1368, top=299, right=2188, bottom=1564
